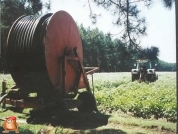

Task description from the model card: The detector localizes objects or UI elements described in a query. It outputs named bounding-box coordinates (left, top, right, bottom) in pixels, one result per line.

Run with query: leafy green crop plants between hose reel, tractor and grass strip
left=89, top=73, right=176, bottom=121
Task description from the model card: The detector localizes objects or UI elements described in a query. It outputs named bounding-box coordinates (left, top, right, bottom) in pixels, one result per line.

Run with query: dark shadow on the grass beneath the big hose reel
left=27, top=111, right=109, bottom=130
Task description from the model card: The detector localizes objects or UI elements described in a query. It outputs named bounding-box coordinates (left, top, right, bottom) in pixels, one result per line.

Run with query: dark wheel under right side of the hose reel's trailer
left=77, top=91, right=98, bottom=112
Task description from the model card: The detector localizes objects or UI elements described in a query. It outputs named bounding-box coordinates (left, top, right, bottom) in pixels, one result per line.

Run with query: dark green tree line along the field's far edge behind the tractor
left=78, top=25, right=175, bottom=72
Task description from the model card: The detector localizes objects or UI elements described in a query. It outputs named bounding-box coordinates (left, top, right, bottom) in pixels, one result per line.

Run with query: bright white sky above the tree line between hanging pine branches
left=42, top=0, right=176, bottom=63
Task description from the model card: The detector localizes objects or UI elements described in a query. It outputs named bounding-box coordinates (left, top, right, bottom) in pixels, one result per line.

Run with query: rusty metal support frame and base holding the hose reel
left=2, top=47, right=99, bottom=108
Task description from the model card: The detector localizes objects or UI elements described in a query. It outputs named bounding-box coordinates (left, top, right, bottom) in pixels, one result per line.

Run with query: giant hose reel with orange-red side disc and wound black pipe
left=7, top=11, right=83, bottom=93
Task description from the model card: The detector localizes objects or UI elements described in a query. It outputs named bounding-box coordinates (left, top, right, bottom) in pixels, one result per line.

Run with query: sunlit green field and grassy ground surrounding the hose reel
left=0, top=72, right=177, bottom=134
